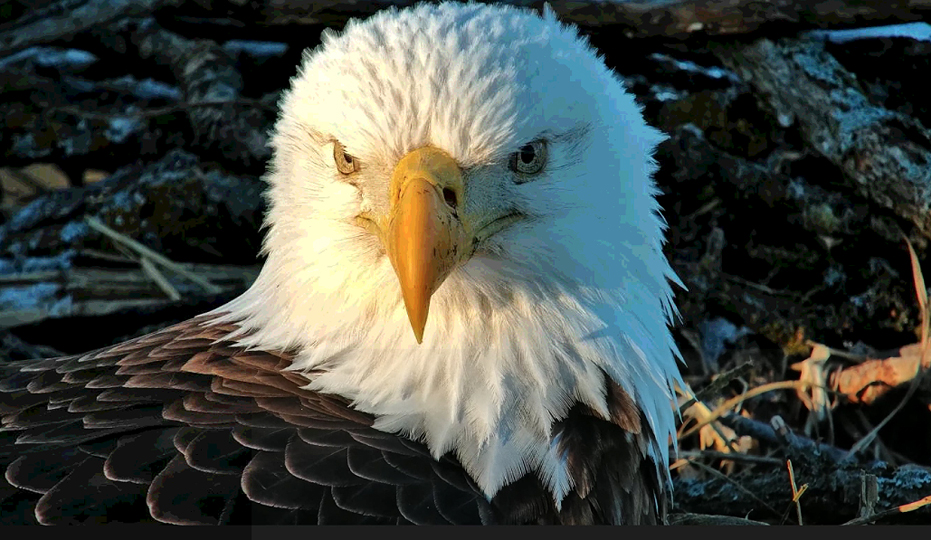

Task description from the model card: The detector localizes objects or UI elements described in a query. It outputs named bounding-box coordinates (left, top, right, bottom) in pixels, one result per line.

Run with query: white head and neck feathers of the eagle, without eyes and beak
left=218, top=3, right=679, bottom=502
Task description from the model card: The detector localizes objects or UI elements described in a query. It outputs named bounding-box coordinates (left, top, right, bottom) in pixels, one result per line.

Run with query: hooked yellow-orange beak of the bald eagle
left=383, top=147, right=472, bottom=343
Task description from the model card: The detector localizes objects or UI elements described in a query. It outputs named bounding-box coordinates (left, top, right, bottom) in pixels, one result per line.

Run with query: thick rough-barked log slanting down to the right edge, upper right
left=718, top=39, right=931, bottom=236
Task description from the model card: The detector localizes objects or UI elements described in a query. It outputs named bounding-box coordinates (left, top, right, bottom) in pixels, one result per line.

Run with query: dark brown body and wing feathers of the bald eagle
left=0, top=316, right=664, bottom=524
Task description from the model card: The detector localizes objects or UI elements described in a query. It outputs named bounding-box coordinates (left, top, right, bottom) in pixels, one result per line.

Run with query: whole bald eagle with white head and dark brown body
left=0, top=3, right=680, bottom=524
